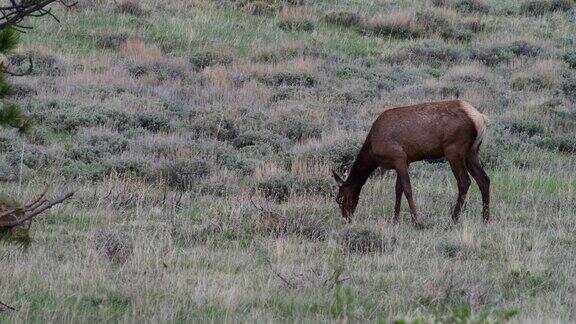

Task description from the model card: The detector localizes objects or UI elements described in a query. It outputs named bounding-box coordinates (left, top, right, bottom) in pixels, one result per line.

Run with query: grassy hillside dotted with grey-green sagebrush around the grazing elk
left=0, top=0, right=576, bottom=323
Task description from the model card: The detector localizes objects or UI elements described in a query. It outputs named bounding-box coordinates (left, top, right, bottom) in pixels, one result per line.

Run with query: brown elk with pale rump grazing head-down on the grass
left=333, top=100, right=490, bottom=226
